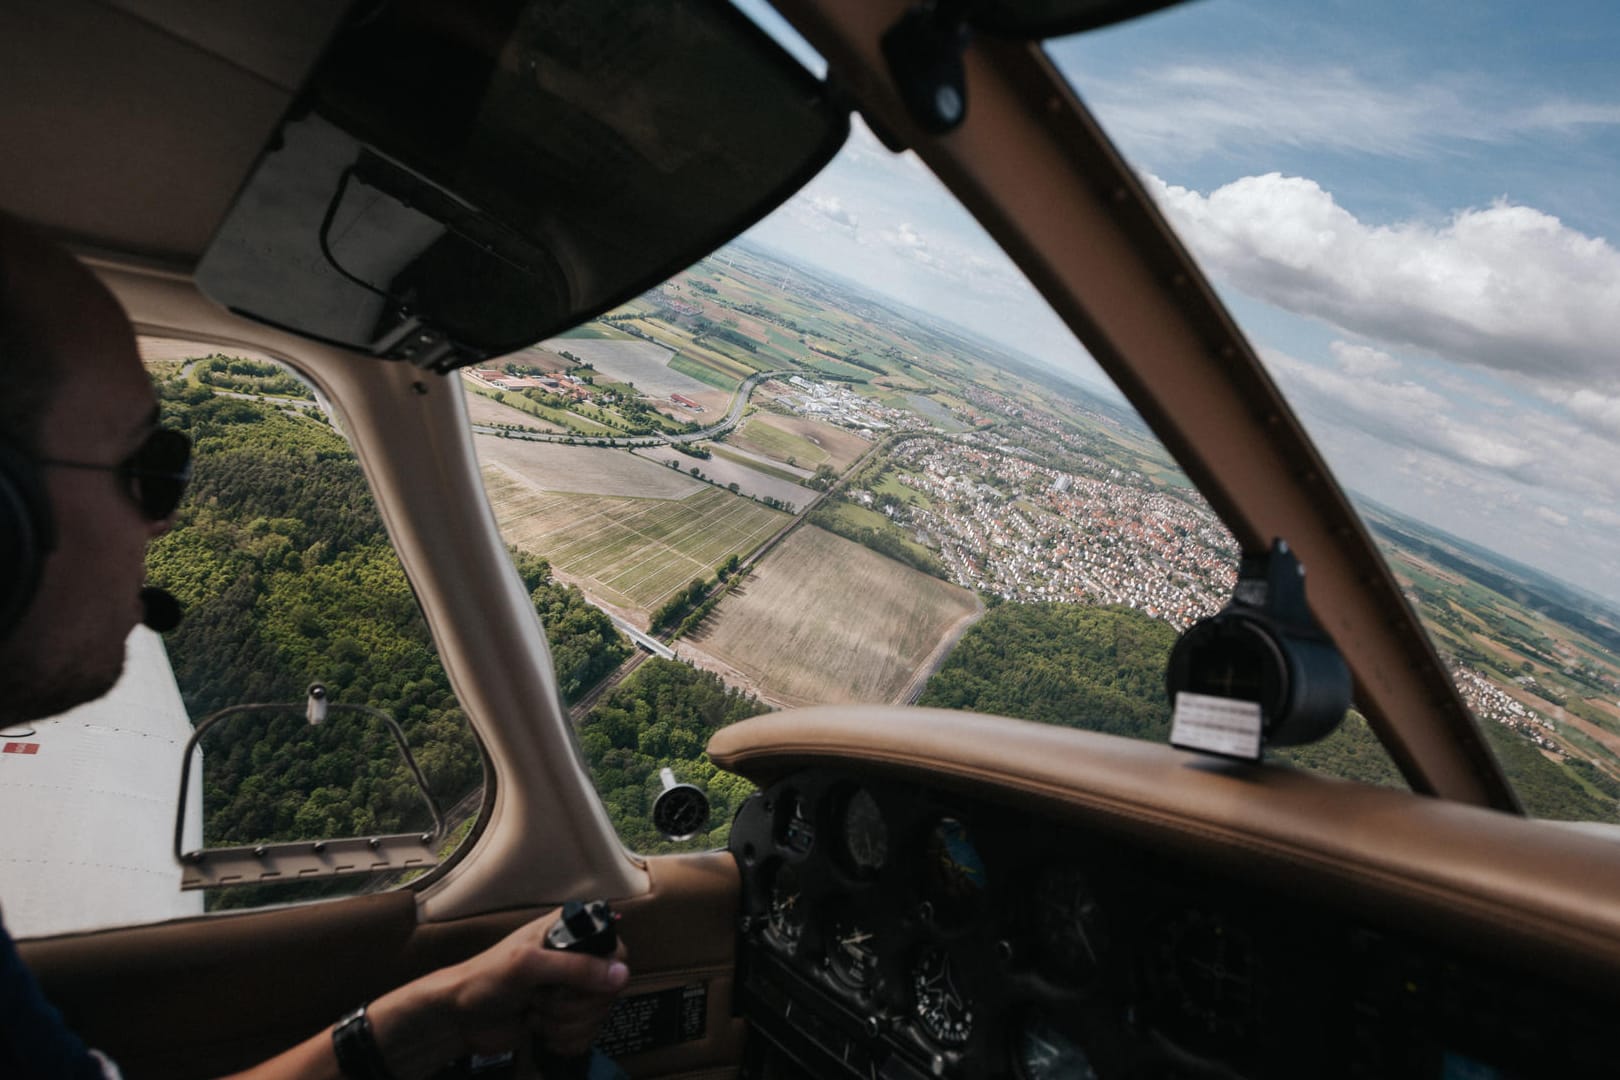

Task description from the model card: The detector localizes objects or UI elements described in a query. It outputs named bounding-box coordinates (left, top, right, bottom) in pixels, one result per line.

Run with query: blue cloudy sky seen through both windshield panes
left=750, top=0, right=1620, bottom=602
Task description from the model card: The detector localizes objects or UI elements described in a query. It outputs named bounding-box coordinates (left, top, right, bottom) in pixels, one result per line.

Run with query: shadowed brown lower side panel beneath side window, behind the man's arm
left=21, top=852, right=744, bottom=1080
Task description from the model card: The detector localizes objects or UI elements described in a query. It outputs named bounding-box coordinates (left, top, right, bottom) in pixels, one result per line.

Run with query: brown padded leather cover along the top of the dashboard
left=708, top=706, right=1620, bottom=980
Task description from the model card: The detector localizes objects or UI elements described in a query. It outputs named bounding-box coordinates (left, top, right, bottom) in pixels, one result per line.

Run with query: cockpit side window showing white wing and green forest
left=6, top=346, right=483, bottom=936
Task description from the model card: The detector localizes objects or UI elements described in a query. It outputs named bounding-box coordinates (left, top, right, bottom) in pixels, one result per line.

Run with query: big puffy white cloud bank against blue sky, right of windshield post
left=1147, top=173, right=1620, bottom=387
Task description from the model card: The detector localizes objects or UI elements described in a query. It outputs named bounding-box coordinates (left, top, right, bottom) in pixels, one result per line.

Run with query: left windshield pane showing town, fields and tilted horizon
left=476, top=110, right=1400, bottom=850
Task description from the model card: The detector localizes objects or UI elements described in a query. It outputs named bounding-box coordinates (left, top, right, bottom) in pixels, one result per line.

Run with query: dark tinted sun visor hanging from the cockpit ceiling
left=196, top=0, right=849, bottom=371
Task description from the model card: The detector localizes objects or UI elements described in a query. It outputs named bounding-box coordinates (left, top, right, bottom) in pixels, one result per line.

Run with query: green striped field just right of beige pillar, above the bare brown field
left=484, top=469, right=789, bottom=614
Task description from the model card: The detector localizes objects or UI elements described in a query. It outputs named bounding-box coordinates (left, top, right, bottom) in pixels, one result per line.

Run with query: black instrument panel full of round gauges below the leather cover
left=731, top=769, right=1614, bottom=1080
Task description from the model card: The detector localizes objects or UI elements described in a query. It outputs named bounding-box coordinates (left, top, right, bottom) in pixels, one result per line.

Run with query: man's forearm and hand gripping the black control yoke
left=232, top=913, right=630, bottom=1080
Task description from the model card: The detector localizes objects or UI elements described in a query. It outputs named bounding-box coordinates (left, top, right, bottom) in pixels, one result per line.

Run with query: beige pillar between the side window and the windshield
left=87, top=257, right=645, bottom=920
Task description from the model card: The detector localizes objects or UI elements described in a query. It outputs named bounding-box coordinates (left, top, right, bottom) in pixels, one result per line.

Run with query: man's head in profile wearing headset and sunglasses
left=0, top=215, right=168, bottom=719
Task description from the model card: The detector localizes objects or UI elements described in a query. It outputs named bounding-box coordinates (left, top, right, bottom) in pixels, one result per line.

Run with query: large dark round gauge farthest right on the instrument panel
left=1165, top=912, right=1257, bottom=1040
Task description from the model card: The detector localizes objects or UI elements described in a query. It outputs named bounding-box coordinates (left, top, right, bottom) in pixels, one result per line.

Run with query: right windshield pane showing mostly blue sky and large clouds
left=1048, top=0, right=1620, bottom=821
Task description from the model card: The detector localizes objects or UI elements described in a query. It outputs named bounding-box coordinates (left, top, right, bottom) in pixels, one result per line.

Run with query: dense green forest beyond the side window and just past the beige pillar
left=147, top=379, right=629, bottom=845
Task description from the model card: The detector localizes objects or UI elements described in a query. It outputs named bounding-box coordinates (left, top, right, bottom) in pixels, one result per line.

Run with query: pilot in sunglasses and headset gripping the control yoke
left=0, top=215, right=630, bottom=1080
